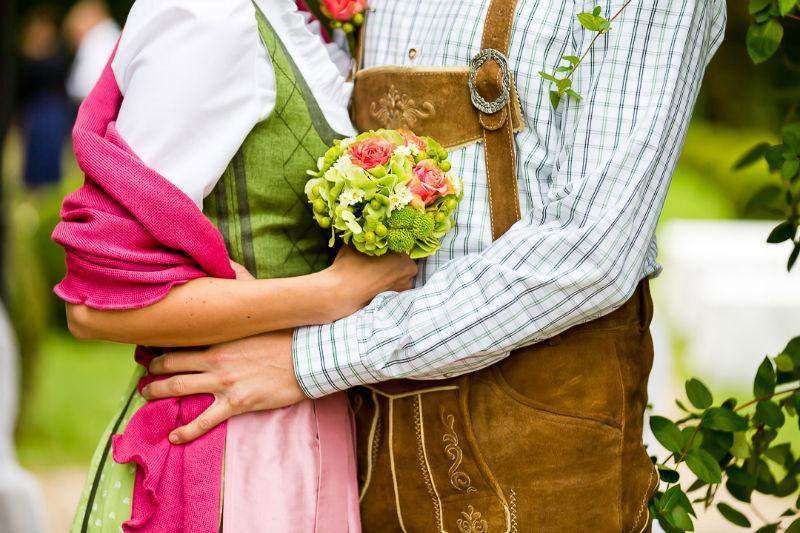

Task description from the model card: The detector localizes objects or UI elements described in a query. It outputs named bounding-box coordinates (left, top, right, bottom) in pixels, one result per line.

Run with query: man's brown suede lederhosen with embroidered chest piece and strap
left=351, top=0, right=658, bottom=533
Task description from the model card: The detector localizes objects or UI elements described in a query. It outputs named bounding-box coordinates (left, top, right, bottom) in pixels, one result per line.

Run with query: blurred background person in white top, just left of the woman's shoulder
left=64, top=0, right=120, bottom=104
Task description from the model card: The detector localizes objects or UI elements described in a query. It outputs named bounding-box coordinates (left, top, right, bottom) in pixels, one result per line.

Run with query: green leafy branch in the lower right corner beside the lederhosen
left=650, top=337, right=800, bottom=533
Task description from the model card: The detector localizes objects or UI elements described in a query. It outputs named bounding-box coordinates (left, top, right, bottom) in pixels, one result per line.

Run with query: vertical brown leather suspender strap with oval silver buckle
left=469, top=0, right=520, bottom=240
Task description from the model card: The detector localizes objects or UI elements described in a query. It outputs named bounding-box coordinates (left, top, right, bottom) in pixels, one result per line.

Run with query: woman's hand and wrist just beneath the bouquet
left=321, top=246, right=417, bottom=322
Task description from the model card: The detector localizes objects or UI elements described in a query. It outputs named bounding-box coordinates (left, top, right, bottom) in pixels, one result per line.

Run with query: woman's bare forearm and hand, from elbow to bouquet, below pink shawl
left=67, top=248, right=417, bottom=347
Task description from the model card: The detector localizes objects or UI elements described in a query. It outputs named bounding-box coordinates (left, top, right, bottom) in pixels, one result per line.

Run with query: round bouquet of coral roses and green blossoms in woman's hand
left=305, top=130, right=462, bottom=259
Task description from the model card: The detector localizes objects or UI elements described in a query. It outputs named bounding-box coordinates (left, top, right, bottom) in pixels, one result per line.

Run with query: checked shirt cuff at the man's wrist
left=292, top=316, right=370, bottom=398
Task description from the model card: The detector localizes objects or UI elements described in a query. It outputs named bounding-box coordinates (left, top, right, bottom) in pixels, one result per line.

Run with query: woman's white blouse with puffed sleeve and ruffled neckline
left=111, top=0, right=355, bottom=206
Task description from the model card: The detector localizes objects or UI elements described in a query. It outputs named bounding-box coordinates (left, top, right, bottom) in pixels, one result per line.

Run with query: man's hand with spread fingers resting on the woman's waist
left=142, top=331, right=305, bottom=444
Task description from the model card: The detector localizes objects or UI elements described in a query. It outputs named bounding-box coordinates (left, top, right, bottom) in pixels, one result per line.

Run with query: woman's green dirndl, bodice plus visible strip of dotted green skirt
left=72, top=7, right=340, bottom=532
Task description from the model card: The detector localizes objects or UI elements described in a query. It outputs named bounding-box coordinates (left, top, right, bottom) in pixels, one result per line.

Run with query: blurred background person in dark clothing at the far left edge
left=17, top=5, right=70, bottom=188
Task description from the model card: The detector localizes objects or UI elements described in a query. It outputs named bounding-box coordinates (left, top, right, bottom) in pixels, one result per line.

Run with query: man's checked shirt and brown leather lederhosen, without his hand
left=294, top=0, right=725, bottom=532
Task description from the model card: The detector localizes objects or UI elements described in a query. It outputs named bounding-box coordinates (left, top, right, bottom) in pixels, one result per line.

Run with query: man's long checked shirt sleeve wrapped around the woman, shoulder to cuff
left=293, top=0, right=725, bottom=397
